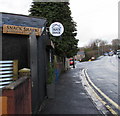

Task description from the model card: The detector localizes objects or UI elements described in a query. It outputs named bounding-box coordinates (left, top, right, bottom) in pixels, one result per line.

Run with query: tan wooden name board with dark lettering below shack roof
left=3, top=24, right=42, bottom=36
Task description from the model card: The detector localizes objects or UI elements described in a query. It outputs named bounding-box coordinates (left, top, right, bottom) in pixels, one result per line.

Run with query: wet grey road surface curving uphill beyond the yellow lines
left=76, top=55, right=120, bottom=112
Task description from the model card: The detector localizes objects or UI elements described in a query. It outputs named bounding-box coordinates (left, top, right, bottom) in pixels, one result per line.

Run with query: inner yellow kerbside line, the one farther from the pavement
left=85, top=70, right=120, bottom=110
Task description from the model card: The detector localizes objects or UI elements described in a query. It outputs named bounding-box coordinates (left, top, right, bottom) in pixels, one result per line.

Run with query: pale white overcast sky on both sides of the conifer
left=0, top=0, right=120, bottom=47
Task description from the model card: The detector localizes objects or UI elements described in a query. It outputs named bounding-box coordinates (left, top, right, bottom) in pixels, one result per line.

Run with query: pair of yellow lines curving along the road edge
left=84, top=69, right=120, bottom=115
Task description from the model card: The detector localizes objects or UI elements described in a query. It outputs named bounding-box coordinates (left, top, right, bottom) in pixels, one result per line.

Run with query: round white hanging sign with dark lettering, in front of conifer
left=49, top=22, right=64, bottom=36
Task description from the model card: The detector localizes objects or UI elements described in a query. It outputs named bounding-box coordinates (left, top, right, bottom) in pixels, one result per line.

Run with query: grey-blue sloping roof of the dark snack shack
left=1, top=13, right=47, bottom=28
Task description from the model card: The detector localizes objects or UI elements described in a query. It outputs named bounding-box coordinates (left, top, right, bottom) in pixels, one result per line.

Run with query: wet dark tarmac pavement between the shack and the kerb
left=39, top=68, right=100, bottom=115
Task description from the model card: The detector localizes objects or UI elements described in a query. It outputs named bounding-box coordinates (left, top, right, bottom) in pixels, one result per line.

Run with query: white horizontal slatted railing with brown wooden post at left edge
left=0, top=60, right=18, bottom=88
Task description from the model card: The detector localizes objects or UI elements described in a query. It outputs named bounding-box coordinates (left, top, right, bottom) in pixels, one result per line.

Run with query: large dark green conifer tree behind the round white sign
left=30, top=2, right=78, bottom=57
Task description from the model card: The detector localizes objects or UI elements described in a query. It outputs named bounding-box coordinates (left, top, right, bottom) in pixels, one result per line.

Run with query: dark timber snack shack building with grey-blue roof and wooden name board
left=2, top=13, right=49, bottom=114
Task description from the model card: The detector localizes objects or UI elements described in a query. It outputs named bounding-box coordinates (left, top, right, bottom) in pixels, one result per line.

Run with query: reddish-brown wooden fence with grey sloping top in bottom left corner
left=0, top=76, right=32, bottom=114
